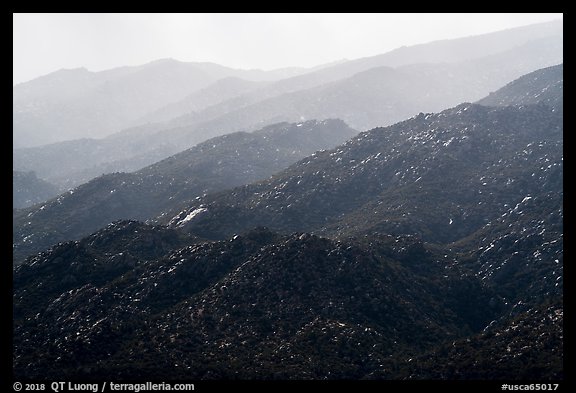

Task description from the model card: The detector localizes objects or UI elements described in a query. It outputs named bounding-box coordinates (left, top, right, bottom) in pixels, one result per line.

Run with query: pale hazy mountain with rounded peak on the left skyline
left=13, top=59, right=310, bottom=147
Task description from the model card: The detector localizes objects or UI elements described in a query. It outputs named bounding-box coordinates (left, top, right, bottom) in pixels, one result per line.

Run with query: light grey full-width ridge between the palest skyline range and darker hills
left=13, top=33, right=562, bottom=187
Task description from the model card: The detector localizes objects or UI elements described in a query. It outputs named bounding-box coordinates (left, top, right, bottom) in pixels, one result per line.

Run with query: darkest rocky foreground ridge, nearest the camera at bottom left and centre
left=14, top=223, right=503, bottom=379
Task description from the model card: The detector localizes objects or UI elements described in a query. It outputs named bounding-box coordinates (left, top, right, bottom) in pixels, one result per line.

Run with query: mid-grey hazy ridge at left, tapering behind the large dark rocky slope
left=13, top=120, right=357, bottom=260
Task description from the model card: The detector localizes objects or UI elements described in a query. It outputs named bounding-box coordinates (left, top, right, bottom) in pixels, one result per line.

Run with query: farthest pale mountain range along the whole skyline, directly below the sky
left=13, top=21, right=562, bottom=148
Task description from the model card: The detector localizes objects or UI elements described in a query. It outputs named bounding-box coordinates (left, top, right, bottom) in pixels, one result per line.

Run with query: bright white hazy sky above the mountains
left=13, top=13, right=562, bottom=83
